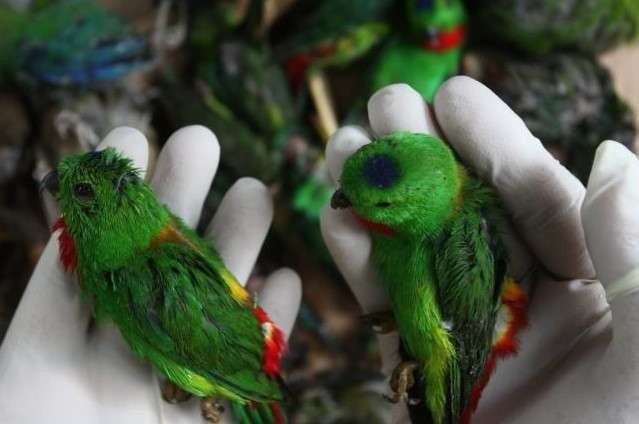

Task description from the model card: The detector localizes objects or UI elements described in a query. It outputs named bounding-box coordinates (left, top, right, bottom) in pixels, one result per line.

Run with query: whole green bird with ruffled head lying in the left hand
left=42, top=149, right=286, bottom=423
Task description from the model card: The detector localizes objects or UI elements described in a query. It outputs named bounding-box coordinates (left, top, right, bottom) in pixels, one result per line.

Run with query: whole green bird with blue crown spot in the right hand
left=331, top=132, right=526, bottom=424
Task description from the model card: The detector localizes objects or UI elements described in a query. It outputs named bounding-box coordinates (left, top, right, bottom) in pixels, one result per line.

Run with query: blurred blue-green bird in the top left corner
left=0, top=0, right=152, bottom=87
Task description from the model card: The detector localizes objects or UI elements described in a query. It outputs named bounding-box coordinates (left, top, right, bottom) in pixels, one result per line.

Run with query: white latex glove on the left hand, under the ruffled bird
left=0, top=126, right=301, bottom=424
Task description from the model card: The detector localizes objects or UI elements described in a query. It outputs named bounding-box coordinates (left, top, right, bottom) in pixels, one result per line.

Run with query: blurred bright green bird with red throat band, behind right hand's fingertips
left=373, top=0, right=466, bottom=101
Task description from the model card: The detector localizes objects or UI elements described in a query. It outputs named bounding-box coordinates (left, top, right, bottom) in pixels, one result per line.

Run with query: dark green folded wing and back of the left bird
left=91, top=224, right=282, bottom=401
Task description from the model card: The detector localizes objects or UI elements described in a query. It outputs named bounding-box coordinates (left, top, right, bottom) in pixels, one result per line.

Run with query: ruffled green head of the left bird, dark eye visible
left=41, top=148, right=167, bottom=267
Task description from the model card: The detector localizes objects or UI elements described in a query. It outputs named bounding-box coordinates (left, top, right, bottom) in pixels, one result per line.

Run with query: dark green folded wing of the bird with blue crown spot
left=435, top=177, right=507, bottom=422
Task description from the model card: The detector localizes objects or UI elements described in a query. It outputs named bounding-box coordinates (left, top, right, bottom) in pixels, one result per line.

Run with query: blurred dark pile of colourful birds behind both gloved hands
left=0, top=0, right=639, bottom=424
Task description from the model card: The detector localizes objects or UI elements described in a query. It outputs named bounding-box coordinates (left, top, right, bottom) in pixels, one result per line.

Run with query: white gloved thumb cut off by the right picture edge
left=581, top=141, right=639, bottom=292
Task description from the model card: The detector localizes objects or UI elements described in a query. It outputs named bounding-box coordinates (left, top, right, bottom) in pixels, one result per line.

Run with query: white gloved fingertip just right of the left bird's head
left=151, top=125, right=220, bottom=227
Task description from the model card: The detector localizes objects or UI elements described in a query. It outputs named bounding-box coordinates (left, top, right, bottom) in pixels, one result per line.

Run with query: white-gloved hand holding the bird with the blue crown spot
left=321, top=77, right=639, bottom=424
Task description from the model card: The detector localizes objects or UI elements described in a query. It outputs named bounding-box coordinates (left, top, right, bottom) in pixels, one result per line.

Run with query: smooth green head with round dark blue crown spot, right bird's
left=331, top=132, right=464, bottom=239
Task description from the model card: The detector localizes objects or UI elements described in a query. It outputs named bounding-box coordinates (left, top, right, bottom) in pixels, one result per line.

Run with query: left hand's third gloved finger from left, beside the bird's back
left=205, top=178, right=273, bottom=284
